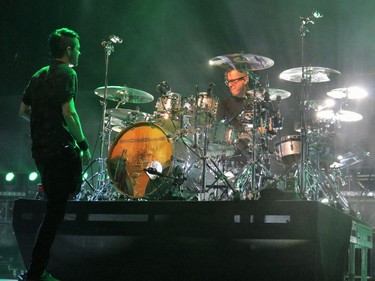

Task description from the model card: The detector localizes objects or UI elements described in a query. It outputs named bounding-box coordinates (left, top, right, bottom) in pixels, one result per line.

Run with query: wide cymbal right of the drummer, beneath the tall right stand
left=280, top=66, right=341, bottom=83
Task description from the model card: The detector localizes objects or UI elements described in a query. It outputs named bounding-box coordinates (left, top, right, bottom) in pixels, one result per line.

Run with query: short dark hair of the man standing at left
left=48, top=27, right=79, bottom=58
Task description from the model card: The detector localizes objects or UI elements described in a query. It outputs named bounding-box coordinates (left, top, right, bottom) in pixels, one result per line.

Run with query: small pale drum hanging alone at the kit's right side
left=275, top=135, right=302, bottom=165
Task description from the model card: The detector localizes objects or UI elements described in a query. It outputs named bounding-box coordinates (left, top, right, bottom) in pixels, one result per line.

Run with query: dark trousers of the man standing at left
left=27, top=146, right=82, bottom=279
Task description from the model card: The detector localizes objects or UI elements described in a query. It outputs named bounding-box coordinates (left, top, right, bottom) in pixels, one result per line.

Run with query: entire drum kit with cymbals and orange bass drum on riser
left=78, top=12, right=366, bottom=207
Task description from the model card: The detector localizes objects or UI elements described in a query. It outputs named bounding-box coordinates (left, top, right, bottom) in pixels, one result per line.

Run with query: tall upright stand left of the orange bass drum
left=78, top=38, right=122, bottom=201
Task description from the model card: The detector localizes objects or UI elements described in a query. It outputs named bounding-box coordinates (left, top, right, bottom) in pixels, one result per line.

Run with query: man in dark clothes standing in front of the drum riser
left=19, top=28, right=91, bottom=281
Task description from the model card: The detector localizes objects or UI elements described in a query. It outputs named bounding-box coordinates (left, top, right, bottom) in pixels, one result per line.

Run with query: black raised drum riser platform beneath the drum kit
left=13, top=200, right=372, bottom=281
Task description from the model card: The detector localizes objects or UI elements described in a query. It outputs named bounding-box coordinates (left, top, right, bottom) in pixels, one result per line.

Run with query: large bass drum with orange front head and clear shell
left=107, top=122, right=200, bottom=199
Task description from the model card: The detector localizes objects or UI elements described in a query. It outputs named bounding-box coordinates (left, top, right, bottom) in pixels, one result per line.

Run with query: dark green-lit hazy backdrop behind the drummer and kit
left=0, top=0, right=375, bottom=177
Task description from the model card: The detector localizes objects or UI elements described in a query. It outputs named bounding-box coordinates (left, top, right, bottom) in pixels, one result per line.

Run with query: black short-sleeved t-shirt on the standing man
left=22, top=61, right=78, bottom=156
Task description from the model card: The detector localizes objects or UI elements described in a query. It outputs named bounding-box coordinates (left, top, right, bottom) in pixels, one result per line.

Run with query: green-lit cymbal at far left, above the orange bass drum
left=95, top=86, right=154, bottom=103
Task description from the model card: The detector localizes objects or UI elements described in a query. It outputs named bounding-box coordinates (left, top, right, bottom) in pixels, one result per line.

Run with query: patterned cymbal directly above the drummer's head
left=209, top=54, right=274, bottom=70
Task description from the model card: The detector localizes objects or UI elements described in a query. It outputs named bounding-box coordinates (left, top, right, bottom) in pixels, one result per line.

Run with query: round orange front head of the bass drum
left=107, top=122, right=173, bottom=198
